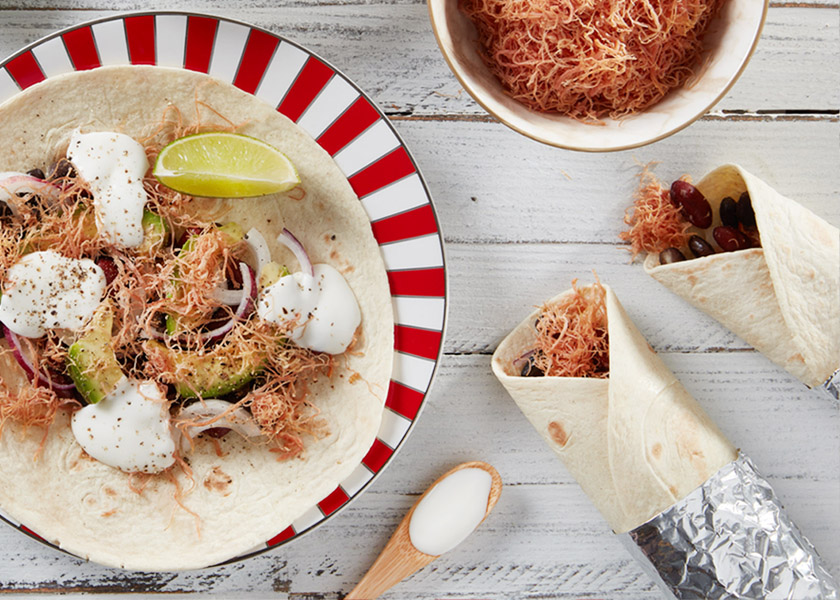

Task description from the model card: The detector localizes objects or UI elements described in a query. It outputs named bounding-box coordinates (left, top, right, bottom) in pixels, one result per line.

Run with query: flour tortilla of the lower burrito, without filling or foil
left=492, top=286, right=736, bottom=533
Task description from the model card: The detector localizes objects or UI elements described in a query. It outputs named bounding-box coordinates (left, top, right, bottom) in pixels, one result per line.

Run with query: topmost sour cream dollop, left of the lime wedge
left=67, top=131, right=149, bottom=248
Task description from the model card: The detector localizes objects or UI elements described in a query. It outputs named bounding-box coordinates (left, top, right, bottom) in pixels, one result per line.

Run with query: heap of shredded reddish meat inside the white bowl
left=459, top=0, right=725, bottom=122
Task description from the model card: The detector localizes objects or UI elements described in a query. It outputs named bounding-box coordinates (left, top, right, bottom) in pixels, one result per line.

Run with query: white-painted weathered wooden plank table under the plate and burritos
left=0, top=0, right=840, bottom=599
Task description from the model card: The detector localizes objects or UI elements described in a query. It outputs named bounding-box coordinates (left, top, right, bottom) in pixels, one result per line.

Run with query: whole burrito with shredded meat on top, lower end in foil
left=492, top=284, right=837, bottom=599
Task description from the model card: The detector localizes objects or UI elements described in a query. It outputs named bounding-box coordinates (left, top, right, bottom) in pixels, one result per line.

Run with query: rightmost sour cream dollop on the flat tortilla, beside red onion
left=257, top=264, right=362, bottom=354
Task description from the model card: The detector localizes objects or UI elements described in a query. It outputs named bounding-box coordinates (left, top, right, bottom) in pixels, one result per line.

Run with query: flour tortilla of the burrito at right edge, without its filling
left=645, top=165, right=840, bottom=387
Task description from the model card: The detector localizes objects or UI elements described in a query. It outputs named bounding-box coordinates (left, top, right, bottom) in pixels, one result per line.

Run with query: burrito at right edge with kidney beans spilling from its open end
left=625, top=165, right=840, bottom=397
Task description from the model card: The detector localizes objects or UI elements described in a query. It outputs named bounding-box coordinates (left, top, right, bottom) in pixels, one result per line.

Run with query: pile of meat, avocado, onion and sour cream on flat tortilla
left=0, top=127, right=361, bottom=473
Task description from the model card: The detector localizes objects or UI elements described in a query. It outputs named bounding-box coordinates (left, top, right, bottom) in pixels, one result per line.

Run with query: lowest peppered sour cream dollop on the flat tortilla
left=71, top=377, right=175, bottom=473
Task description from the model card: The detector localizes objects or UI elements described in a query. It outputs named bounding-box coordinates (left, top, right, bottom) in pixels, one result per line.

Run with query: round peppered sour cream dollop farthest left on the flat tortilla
left=0, top=250, right=105, bottom=338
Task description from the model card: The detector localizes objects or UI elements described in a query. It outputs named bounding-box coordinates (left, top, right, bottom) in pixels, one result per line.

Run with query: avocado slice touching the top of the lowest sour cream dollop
left=67, top=302, right=124, bottom=404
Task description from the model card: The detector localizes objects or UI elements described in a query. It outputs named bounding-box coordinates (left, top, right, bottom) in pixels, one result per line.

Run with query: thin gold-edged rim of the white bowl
left=427, top=0, right=770, bottom=153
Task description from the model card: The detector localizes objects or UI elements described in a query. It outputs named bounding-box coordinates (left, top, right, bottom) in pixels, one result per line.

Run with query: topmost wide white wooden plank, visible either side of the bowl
left=0, top=6, right=840, bottom=116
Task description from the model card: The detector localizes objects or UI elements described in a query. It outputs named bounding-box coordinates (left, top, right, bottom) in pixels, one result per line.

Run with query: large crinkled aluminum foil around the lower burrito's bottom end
left=620, top=454, right=840, bottom=600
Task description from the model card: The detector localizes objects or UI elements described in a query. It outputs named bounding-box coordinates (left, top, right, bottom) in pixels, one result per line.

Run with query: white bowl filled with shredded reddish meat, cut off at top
left=429, top=0, right=768, bottom=152
